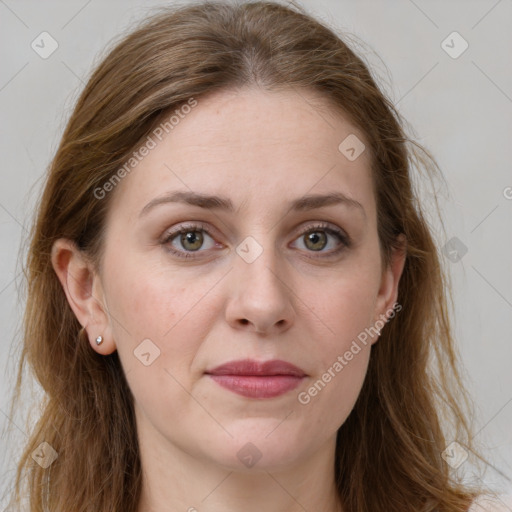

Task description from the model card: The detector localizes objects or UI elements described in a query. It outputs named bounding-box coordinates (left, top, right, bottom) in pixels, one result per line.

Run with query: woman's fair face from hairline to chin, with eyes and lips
left=54, top=85, right=401, bottom=470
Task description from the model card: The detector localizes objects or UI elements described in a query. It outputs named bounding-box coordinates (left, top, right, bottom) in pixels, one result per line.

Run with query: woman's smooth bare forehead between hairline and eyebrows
left=106, top=88, right=372, bottom=220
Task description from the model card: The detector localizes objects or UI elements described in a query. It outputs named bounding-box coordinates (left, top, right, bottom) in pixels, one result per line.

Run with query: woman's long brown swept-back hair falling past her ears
left=5, top=1, right=488, bottom=512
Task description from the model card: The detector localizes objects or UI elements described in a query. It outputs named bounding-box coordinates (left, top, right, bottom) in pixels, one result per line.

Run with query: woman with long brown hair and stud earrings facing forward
left=4, top=2, right=508, bottom=512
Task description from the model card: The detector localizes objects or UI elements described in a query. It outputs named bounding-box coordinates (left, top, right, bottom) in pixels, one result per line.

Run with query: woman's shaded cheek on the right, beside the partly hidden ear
left=298, top=265, right=379, bottom=433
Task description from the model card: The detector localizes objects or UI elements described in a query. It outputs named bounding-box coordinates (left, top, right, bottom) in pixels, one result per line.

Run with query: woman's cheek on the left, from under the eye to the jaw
left=108, top=263, right=208, bottom=429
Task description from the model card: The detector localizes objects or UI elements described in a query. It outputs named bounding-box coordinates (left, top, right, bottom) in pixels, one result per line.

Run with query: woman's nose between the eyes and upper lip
left=226, top=241, right=295, bottom=335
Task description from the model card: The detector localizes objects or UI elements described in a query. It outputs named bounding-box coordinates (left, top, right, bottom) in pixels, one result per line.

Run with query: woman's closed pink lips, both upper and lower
left=206, top=359, right=306, bottom=398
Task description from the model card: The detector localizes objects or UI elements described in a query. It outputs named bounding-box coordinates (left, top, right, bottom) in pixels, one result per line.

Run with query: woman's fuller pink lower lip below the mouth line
left=209, top=375, right=304, bottom=398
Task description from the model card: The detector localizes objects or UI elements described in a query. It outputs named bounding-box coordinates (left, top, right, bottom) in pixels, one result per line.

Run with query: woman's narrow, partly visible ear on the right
left=374, top=234, right=407, bottom=342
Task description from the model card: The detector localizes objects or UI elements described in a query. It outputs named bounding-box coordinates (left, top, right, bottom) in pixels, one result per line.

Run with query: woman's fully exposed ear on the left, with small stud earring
left=51, top=238, right=116, bottom=355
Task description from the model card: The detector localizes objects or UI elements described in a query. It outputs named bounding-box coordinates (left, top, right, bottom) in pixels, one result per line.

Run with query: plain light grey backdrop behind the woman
left=0, top=0, right=512, bottom=510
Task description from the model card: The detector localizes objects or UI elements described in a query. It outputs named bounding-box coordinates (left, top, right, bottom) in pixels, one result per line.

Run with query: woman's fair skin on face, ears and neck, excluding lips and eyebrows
left=52, top=88, right=405, bottom=512
